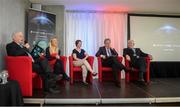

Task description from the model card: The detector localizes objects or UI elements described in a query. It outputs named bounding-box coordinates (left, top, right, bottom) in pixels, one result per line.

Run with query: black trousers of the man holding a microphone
left=32, top=59, right=55, bottom=91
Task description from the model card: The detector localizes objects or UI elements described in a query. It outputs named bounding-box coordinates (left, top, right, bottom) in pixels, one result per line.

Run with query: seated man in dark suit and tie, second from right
left=96, top=38, right=128, bottom=87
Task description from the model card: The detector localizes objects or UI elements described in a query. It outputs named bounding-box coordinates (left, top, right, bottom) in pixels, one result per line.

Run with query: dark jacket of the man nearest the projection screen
left=123, top=48, right=148, bottom=63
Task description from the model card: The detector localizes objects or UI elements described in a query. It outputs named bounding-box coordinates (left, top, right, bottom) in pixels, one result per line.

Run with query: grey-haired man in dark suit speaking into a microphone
left=6, top=32, right=60, bottom=93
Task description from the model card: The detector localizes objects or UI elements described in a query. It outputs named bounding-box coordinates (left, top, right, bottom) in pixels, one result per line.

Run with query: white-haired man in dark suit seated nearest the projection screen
left=123, top=40, right=152, bottom=83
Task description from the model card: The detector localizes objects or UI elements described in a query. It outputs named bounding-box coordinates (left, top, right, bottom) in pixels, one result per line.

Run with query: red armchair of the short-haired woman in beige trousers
left=69, top=56, right=94, bottom=84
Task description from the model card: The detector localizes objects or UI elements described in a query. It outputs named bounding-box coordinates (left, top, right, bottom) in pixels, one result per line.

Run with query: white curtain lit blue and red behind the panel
left=65, top=11, right=127, bottom=78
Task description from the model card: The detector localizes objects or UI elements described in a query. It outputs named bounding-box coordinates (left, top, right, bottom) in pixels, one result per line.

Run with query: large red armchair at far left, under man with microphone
left=5, top=56, right=42, bottom=96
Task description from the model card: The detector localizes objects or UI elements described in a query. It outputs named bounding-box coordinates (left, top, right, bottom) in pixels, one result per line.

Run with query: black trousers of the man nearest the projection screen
left=132, top=57, right=147, bottom=80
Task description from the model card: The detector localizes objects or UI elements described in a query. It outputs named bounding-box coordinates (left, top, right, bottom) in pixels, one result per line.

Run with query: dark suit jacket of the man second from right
left=96, top=46, right=118, bottom=57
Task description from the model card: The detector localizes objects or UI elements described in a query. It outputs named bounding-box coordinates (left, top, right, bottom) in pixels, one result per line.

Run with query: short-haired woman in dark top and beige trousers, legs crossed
left=72, top=40, right=97, bottom=85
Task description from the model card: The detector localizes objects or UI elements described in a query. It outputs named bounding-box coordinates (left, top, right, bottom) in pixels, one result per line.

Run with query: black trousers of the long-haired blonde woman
left=54, top=59, right=68, bottom=79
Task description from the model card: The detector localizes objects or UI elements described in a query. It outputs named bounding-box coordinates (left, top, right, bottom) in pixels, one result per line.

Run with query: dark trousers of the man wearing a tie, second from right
left=102, top=57, right=125, bottom=82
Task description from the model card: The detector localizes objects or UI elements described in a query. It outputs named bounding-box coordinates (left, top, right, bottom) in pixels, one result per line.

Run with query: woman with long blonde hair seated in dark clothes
left=46, top=37, right=70, bottom=81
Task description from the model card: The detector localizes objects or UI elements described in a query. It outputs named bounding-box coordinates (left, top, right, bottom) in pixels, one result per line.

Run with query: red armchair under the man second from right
left=98, top=56, right=123, bottom=82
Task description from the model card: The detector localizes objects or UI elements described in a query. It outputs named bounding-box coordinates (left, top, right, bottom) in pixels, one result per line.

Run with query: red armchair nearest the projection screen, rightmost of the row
left=125, top=57, right=150, bottom=83
